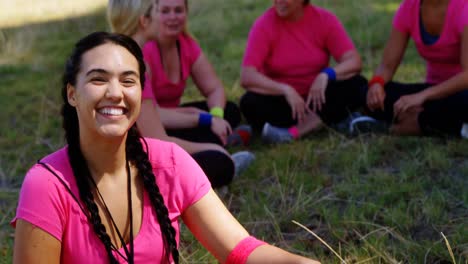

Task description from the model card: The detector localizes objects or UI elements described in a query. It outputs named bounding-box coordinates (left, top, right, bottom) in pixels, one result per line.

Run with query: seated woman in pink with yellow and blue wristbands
left=143, top=0, right=249, bottom=146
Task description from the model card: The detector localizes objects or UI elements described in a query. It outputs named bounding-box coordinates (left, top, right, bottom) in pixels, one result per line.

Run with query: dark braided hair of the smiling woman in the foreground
left=62, top=32, right=179, bottom=264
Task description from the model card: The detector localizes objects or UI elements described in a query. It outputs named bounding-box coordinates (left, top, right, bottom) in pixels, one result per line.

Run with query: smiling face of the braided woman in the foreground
left=67, top=43, right=141, bottom=140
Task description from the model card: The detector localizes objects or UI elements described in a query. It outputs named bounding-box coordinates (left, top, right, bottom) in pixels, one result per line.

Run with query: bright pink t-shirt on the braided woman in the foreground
left=12, top=138, right=211, bottom=263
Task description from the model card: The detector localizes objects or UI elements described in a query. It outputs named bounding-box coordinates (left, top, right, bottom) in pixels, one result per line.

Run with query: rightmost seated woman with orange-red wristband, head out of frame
left=367, top=0, right=468, bottom=135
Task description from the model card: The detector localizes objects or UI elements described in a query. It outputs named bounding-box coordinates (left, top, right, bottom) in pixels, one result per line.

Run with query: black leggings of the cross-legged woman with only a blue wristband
left=240, top=75, right=367, bottom=132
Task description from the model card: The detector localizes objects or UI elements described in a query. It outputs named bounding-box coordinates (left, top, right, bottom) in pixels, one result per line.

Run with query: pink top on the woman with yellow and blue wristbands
left=142, top=34, right=201, bottom=107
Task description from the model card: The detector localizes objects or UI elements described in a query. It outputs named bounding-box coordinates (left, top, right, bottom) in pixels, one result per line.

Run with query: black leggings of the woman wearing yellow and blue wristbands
left=166, top=101, right=241, bottom=145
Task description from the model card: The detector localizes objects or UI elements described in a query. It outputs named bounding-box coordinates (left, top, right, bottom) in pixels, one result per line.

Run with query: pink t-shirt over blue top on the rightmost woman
left=393, top=0, right=468, bottom=84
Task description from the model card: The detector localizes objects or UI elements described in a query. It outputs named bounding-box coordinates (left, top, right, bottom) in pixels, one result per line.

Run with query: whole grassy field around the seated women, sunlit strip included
left=0, top=0, right=468, bottom=264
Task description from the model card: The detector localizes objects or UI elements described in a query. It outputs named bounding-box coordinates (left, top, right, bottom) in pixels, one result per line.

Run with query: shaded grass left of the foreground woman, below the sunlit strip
left=0, top=9, right=107, bottom=263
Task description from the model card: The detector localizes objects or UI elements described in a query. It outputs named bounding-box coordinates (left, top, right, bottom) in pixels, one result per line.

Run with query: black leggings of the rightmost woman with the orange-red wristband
left=369, top=82, right=468, bottom=135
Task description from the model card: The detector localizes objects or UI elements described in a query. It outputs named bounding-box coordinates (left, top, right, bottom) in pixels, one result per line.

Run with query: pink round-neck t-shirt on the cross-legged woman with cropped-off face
left=242, top=5, right=355, bottom=96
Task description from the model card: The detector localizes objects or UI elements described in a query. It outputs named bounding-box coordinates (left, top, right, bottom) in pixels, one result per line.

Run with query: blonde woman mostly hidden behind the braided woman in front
left=107, top=0, right=254, bottom=187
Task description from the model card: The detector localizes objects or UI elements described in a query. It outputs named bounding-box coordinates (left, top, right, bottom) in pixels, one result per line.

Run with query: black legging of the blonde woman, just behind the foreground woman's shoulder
left=192, top=150, right=234, bottom=188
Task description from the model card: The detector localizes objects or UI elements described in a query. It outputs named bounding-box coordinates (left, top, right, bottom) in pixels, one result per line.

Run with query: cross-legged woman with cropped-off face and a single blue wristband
left=240, top=0, right=366, bottom=142
